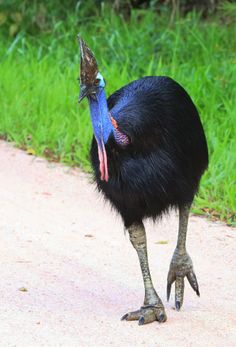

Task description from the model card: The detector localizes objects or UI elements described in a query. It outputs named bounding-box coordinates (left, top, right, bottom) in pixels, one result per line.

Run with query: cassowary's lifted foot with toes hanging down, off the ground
left=167, top=249, right=200, bottom=311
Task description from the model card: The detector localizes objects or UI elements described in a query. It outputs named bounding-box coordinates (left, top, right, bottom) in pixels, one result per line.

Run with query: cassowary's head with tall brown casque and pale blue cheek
left=78, top=36, right=105, bottom=102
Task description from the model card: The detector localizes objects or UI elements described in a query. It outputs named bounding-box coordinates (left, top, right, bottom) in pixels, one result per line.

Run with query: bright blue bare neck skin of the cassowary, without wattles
left=88, top=88, right=113, bottom=144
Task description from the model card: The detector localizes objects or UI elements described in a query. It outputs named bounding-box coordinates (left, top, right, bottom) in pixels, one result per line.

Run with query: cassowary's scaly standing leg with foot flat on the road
left=121, top=223, right=167, bottom=325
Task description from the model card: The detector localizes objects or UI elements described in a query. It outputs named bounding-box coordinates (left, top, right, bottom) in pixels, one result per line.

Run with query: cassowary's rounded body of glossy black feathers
left=91, top=76, right=208, bottom=227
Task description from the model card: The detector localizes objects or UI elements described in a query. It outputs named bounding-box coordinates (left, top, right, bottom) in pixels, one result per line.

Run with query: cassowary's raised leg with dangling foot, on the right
left=167, top=205, right=200, bottom=311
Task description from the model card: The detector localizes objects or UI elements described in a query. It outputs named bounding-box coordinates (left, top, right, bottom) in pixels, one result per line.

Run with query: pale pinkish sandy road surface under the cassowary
left=0, top=142, right=236, bottom=347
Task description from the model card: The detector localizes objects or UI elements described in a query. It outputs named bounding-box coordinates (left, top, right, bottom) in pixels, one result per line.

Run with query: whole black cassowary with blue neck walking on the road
left=79, top=38, right=208, bottom=325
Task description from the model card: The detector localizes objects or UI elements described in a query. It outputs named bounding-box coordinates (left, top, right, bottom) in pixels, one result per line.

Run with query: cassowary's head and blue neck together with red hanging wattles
left=79, top=37, right=113, bottom=181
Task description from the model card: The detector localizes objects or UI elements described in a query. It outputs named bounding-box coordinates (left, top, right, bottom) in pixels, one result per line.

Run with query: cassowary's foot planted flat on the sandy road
left=121, top=302, right=167, bottom=325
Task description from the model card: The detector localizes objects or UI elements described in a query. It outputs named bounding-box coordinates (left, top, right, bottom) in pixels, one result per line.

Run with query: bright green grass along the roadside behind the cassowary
left=0, top=11, right=236, bottom=225
